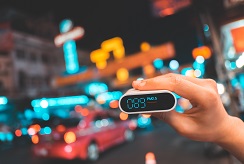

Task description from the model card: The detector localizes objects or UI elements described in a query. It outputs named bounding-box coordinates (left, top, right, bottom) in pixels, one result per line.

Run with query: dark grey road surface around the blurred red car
left=0, top=123, right=233, bottom=164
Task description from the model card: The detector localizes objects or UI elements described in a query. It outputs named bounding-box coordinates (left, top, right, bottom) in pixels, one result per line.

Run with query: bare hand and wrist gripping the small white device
left=132, top=73, right=244, bottom=163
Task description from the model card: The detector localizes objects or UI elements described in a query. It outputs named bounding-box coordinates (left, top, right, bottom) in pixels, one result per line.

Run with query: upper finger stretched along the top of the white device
left=132, top=74, right=205, bottom=102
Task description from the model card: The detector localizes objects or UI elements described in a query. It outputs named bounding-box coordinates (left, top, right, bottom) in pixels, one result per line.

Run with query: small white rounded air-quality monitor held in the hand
left=119, top=89, right=177, bottom=114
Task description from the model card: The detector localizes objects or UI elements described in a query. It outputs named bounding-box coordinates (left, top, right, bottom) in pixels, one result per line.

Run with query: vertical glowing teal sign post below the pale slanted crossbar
left=63, top=40, right=79, bottom=74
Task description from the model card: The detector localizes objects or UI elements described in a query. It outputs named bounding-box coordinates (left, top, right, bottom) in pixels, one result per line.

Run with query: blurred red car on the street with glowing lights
left=32, top=110, right=136, bottom=161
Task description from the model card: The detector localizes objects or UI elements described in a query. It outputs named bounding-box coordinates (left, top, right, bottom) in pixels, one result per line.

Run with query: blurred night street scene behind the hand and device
left=0, top=0, right=244, bottom=164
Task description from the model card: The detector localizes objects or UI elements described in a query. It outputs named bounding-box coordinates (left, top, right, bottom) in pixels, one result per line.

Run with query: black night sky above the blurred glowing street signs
left=1, top=0, right=199, bottom=64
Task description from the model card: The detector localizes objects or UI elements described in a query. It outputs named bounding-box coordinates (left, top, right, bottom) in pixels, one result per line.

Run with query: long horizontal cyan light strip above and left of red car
left=31, top=95, right=89, bottom=108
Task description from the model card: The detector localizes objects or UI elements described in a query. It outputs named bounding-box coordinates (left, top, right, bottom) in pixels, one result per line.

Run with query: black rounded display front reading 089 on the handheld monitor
left=120, top=92, right=176, bottom=113
